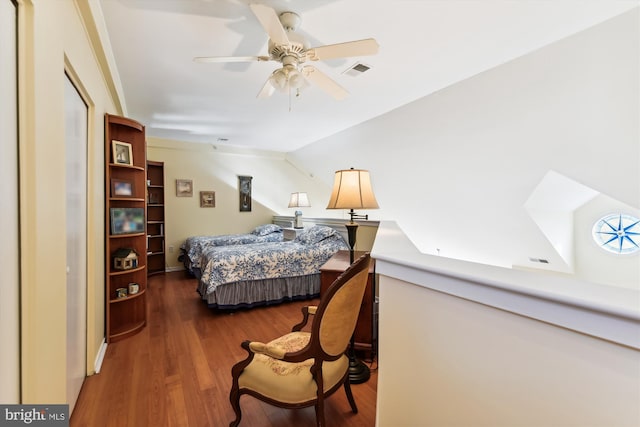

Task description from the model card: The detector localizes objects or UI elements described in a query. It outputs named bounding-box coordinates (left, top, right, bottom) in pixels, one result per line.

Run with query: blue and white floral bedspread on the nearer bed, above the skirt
left=199, top=225, right=349, bottom=296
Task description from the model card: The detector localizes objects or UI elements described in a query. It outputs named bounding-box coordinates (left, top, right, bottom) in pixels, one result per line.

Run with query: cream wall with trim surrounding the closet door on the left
left=18, top=0, right=116, bottom=404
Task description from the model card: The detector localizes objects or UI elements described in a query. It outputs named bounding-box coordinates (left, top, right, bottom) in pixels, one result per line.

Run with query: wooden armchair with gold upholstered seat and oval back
left=229, top=254, right=371, bottom=427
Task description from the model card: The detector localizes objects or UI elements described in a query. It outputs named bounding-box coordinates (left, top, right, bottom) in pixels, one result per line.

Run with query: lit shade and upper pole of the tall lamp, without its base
left=327, top=168, right=379, bottom=263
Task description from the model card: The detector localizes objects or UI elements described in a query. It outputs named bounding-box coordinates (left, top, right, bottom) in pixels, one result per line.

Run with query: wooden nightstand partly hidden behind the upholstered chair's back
left=320, top=251, right=377, bottom=358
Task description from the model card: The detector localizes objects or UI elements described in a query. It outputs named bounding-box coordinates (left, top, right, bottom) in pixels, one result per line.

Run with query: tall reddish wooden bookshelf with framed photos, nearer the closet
left=105, top=114, right=147, bottom=342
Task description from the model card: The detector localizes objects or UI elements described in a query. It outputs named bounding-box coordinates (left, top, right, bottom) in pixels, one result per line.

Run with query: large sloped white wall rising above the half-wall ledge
left=289, top=9, right=640, bottom=284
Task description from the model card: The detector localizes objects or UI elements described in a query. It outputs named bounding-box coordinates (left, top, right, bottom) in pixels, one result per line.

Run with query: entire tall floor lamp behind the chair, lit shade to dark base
left=327, top=168, right=379, bottom=384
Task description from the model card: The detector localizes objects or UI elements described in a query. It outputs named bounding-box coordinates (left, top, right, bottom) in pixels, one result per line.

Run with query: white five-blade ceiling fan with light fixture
left=194, top=4, right=378, bottom=100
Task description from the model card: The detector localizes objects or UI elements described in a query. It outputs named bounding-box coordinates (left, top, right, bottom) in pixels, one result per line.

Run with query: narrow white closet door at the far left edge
left=0, top=0, right=20, bottom=403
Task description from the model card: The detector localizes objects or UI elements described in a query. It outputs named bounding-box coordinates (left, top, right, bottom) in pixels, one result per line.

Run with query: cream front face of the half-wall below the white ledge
left=377, top=277, right=640, bottom=427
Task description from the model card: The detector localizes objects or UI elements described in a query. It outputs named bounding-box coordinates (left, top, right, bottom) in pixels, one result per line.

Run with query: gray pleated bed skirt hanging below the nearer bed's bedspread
left=198, top=273, right=320, bottom=310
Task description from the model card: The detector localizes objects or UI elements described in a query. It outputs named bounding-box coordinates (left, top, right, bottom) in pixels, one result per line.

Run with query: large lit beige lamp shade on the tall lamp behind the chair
left=327, top=168, right=379, bottom=209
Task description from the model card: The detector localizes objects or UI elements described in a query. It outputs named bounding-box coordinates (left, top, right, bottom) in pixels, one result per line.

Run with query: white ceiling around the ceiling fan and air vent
left=100, top=0, right=638, bottom=152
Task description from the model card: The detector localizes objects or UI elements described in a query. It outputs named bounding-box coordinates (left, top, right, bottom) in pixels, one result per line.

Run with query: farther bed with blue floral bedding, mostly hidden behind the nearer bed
left=180, top=224, right=283, bottom=278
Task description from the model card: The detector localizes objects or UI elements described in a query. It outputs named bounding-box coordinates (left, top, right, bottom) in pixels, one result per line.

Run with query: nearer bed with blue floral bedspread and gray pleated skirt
left=198, top=225, right=348, bottom=310
